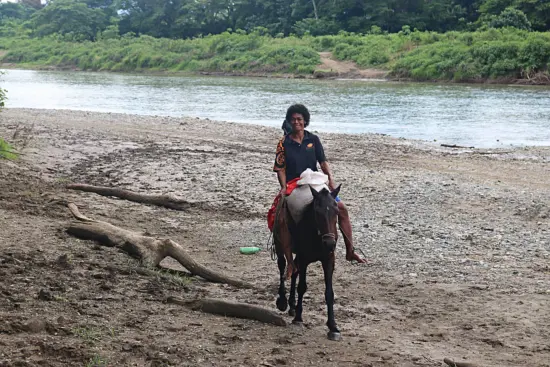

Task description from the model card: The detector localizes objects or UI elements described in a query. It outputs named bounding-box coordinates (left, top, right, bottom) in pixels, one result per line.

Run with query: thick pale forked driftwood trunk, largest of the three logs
left=67, top=203, right=254, bottom=288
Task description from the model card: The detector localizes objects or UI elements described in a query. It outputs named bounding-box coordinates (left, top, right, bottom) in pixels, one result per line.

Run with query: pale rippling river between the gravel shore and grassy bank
left=0, top=70, right=550, bottom=147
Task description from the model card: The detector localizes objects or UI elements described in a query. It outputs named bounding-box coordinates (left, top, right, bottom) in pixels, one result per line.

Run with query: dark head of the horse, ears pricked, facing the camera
left=310, top=186, right=340, bottom=252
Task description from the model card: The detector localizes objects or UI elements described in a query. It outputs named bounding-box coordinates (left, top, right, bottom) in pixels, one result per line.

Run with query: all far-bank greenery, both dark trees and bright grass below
left=0, top=0, right=550, bottom=82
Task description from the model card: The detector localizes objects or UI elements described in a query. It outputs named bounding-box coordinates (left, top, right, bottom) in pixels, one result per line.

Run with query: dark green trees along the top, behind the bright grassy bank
left=0, top=0, right=550, bottom=40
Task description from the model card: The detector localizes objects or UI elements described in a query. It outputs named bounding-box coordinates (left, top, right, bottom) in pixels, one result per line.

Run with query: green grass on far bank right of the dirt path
left=312, top=28, right=550, bottom=81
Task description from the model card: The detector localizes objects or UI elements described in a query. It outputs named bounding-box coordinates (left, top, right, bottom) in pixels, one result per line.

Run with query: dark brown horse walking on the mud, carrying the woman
left=275, top=186, right=340, bottom=340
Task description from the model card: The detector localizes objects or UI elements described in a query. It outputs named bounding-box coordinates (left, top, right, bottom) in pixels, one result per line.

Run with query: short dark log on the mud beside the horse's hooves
left=166, top=297, right=286, bottom=326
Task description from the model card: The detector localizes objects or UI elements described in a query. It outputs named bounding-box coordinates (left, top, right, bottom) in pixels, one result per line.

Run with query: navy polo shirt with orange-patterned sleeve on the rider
left=273, top=130, right=327, bottom=182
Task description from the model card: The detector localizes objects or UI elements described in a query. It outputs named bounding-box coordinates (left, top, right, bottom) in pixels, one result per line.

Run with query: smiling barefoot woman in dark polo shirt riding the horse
left=273, top=104, right=366, bottom=272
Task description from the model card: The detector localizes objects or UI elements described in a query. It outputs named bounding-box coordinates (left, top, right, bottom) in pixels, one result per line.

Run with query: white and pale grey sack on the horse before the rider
left=285, top=168, right=329, bottom=223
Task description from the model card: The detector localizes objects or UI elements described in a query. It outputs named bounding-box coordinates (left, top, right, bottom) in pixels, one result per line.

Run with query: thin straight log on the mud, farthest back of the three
left=67, top=184, right=194, bottom=210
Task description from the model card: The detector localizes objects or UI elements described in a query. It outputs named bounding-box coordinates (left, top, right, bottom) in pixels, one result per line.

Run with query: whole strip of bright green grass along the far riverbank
left=0, top=29, right=550, bottom=83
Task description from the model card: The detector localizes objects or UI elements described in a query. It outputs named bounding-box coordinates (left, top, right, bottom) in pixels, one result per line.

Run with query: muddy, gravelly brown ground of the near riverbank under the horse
left=0, top=109, right=550, bottom=367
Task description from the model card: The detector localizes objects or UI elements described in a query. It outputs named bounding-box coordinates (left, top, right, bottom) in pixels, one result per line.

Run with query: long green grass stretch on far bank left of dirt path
left=0, top=33, right=319, bottom=74
